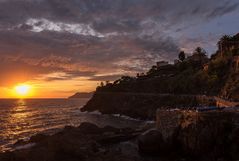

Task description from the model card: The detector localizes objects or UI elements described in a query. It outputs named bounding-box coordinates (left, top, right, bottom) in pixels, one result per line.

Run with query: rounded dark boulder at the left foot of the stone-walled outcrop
left=138, top=129, right=165, bottom=156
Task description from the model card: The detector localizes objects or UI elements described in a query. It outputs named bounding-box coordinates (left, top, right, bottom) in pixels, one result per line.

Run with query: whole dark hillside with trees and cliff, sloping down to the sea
left=82, top=34, right=239, bottom=119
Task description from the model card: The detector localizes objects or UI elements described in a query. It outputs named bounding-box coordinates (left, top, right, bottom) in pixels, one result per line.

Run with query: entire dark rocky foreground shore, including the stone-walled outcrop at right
left=0, top=110, right=239, bottom=161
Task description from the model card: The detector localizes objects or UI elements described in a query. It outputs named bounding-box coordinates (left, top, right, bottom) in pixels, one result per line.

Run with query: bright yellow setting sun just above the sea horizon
left=14, top=84, right=32, bottom=98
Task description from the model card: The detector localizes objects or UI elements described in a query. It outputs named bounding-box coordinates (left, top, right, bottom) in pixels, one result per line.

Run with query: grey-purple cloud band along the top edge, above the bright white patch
left=0, top=0, right=238, bottom=31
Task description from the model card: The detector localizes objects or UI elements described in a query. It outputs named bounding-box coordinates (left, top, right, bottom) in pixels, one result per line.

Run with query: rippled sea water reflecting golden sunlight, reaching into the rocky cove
left=0, top=99, right=145, bottom=151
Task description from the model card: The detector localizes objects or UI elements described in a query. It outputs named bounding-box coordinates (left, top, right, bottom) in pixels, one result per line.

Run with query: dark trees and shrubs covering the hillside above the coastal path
left=97, top=36, right=239, bottom=98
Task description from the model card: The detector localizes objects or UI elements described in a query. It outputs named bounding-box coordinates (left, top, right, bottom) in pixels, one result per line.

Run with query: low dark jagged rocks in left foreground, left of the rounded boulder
left=0, top=123, right=144, bottom=161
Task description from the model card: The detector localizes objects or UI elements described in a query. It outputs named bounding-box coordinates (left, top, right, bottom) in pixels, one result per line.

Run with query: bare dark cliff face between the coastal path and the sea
left=82, top=92, right=215, bottom=119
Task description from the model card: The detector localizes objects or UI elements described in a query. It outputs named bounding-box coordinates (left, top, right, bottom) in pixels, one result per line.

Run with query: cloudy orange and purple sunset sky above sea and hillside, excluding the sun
left=0, top=0, right=239, bottom=98
